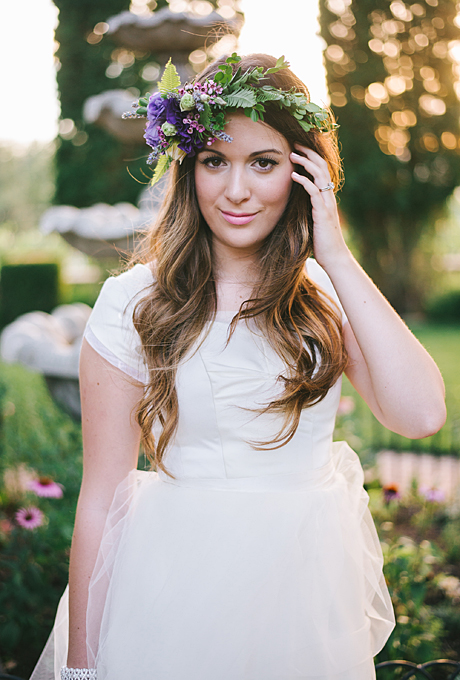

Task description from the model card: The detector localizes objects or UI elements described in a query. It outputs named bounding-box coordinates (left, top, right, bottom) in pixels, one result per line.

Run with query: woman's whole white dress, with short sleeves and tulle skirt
left=31, top=260, right=394, bottom=680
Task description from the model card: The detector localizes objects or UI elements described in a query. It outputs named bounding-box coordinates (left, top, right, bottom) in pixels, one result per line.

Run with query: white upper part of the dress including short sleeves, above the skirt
left=85, top=263, right=341, bottom=479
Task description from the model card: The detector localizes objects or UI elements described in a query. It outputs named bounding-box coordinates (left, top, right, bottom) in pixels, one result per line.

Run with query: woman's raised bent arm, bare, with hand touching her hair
left=291, top=145, right=446, bottom=439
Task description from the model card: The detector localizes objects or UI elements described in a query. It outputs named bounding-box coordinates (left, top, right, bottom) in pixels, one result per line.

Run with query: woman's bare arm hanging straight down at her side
left=67, top=340, right=143, bottom=668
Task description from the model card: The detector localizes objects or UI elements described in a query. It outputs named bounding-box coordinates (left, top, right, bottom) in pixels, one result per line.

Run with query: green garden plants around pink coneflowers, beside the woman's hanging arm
left=0, top=364, right=81, bottom=677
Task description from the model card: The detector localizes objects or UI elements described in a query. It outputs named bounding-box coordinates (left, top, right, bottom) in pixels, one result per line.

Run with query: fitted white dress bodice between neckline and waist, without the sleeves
left=165, top=315, right=340, bottom=478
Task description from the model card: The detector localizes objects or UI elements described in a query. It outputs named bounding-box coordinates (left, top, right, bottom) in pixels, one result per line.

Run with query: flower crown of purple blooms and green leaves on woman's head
left=123, top=53, right=338, bottom=185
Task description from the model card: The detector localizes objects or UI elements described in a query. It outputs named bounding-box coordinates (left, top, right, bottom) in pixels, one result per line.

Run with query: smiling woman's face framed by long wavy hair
left=195, top=111, right=294, bottom=254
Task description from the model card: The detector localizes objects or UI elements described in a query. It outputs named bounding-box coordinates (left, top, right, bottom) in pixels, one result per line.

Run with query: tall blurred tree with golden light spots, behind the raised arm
left=320, top=0, right=460, bottom=312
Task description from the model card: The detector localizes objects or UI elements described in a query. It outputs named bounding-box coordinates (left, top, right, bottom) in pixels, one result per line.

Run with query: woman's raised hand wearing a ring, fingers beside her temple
left=291, top=144, right=348, bottom=269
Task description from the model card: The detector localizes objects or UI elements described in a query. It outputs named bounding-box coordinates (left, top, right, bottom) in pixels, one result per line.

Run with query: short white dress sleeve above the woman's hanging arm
left=83, top=264, right=153, bottom=383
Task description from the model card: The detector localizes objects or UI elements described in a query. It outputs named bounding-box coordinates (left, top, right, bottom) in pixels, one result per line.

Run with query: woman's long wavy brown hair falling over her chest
left=128, top=54, right=346, bottom=477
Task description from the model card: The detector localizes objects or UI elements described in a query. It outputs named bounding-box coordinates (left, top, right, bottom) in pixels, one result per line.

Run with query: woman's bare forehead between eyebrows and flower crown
left=203, top=111, right=290, bottom=156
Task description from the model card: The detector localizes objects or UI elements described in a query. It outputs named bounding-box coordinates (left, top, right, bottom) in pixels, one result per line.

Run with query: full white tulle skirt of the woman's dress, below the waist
left=31, top=442, right=394, bottom=680
